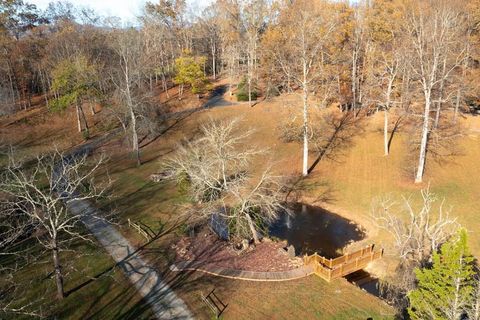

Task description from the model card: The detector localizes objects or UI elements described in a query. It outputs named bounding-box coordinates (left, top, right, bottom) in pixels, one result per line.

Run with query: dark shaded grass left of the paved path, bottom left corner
left=0, top=239, right=152, bottom=319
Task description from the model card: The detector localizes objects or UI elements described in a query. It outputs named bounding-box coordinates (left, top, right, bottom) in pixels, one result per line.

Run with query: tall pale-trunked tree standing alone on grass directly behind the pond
left=262, top=1, right=336, bottom=176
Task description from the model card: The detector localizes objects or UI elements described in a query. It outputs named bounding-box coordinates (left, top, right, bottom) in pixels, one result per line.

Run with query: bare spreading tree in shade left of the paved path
left=0, top=151, right=106, bottom=299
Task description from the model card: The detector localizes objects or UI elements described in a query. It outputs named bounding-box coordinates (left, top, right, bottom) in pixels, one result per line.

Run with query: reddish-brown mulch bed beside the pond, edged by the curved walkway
left=172, top=230, right=303, bottom=272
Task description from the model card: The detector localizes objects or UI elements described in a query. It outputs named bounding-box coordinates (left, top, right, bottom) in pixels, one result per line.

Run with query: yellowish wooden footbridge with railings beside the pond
left=303, top=244, right=383, bottom=281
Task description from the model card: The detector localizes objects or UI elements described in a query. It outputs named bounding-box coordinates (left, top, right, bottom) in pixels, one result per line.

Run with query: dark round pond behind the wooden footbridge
left=269, top=204, right=365, bottom=258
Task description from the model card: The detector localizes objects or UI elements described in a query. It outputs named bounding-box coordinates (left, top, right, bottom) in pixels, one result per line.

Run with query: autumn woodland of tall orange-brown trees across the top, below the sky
left=0, top=0, right=480, bottom=182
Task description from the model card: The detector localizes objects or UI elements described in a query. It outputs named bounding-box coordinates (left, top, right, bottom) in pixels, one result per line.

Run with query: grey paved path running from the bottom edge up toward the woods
left=63, top=89, right=244, bottom=320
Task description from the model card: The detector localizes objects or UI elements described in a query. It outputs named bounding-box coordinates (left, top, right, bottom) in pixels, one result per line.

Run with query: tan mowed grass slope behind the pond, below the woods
left=102, top=93, right=480, bottom=256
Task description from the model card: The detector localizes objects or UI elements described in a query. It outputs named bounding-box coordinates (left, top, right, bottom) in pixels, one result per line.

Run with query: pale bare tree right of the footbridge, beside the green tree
left=372, top=188, right=459, bottom=312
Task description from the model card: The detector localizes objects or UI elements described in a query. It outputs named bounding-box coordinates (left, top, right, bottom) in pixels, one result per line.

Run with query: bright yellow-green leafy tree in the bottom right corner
left=408, top=229, right=475, bottom=320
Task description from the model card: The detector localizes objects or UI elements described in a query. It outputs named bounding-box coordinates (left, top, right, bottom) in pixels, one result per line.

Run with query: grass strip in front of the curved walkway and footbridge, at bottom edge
left=172, top=273, right=393, bottom=320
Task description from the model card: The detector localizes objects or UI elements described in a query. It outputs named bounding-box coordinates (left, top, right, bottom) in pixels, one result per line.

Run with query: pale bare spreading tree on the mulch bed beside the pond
left=164, top=119, right=285, bottom=242
